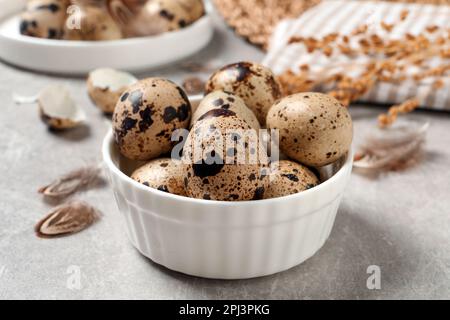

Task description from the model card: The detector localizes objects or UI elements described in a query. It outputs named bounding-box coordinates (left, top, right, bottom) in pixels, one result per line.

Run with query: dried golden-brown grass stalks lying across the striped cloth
left=278, top=11, right=450, bottom=108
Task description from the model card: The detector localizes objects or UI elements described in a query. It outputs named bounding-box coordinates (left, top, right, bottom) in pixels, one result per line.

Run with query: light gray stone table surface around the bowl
left=0, top=6, right=450, bottom=299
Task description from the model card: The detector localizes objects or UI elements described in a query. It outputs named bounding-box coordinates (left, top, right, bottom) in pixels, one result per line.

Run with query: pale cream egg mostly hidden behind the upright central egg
left=191, top=91, right=260, bottom=130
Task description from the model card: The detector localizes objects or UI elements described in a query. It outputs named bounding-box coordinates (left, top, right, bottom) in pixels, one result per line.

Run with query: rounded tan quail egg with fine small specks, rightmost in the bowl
left=267, top=92, right=353, bottom=166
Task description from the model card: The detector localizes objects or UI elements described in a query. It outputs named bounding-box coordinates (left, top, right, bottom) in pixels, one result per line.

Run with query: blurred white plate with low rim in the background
left=0, top=0, right=214, bottom=75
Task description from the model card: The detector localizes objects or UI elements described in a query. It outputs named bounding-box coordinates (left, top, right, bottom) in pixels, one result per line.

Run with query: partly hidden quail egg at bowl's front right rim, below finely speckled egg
left=264, top=160, right=319, bottom=199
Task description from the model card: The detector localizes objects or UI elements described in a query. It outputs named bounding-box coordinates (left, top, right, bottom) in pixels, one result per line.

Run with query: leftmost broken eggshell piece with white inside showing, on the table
left=37, top=84, right=86, bottom=130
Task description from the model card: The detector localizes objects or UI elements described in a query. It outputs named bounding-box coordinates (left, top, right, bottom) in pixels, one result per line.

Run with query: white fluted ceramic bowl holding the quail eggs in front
left=103, top=131, right=353, bottom=279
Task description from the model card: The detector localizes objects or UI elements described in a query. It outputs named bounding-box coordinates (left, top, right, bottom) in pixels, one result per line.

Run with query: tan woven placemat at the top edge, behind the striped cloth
left=214, top=0, right=450, bottom=50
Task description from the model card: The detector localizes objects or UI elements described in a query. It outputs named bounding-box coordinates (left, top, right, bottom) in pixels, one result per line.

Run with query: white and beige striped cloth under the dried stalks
left=263, top=0, right=450, bottom=111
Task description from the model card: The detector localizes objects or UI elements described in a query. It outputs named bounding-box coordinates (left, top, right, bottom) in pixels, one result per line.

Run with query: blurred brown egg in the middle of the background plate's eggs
left=64, top=5, right=123, bottom=41
